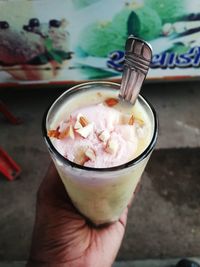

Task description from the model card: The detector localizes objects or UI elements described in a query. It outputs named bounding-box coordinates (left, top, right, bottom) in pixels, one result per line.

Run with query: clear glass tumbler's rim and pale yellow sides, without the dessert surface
left=43, top=82, right=158, bottom=225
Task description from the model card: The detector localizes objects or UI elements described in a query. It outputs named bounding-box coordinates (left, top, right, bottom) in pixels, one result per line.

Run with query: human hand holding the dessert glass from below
left=26, top=164, right=128, bottom=267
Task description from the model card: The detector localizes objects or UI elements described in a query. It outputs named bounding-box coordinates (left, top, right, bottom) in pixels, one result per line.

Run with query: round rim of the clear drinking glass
left=42, top=81, right=158, bottom=173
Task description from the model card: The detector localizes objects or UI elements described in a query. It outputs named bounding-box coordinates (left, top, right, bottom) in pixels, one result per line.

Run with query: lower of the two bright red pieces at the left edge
left=0, top=147, right=21, bottom=181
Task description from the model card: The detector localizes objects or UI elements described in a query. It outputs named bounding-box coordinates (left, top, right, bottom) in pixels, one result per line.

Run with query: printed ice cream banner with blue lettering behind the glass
left=0, top=0, right=200, bottom=86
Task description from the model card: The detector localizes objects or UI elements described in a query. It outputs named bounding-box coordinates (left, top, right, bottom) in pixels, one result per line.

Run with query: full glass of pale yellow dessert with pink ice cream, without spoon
left=44, top=82, right=156, bottom=225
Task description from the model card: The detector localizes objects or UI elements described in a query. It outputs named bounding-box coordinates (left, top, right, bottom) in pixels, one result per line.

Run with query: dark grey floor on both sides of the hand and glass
left=0, top=81, right=200, bottom=267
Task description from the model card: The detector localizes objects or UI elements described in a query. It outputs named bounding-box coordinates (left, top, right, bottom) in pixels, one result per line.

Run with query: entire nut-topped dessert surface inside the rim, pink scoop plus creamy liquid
left=49, top=87, right=152, bottom=168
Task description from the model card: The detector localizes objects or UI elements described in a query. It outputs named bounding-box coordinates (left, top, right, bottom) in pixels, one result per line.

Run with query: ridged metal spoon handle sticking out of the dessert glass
left=119, top=35, right=152, bottom=104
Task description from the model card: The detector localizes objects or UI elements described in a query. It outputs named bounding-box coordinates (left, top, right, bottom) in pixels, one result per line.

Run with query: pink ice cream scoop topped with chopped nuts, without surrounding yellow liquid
left=49, top=103, right=144, bottom=168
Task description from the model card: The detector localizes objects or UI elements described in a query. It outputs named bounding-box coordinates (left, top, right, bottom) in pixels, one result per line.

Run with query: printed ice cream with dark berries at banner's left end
left=0, top=18, right=72, bottom=80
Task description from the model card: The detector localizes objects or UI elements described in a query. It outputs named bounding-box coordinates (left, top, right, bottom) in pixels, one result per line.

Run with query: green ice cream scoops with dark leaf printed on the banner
left=79, top=6, right=162, bottom=57
